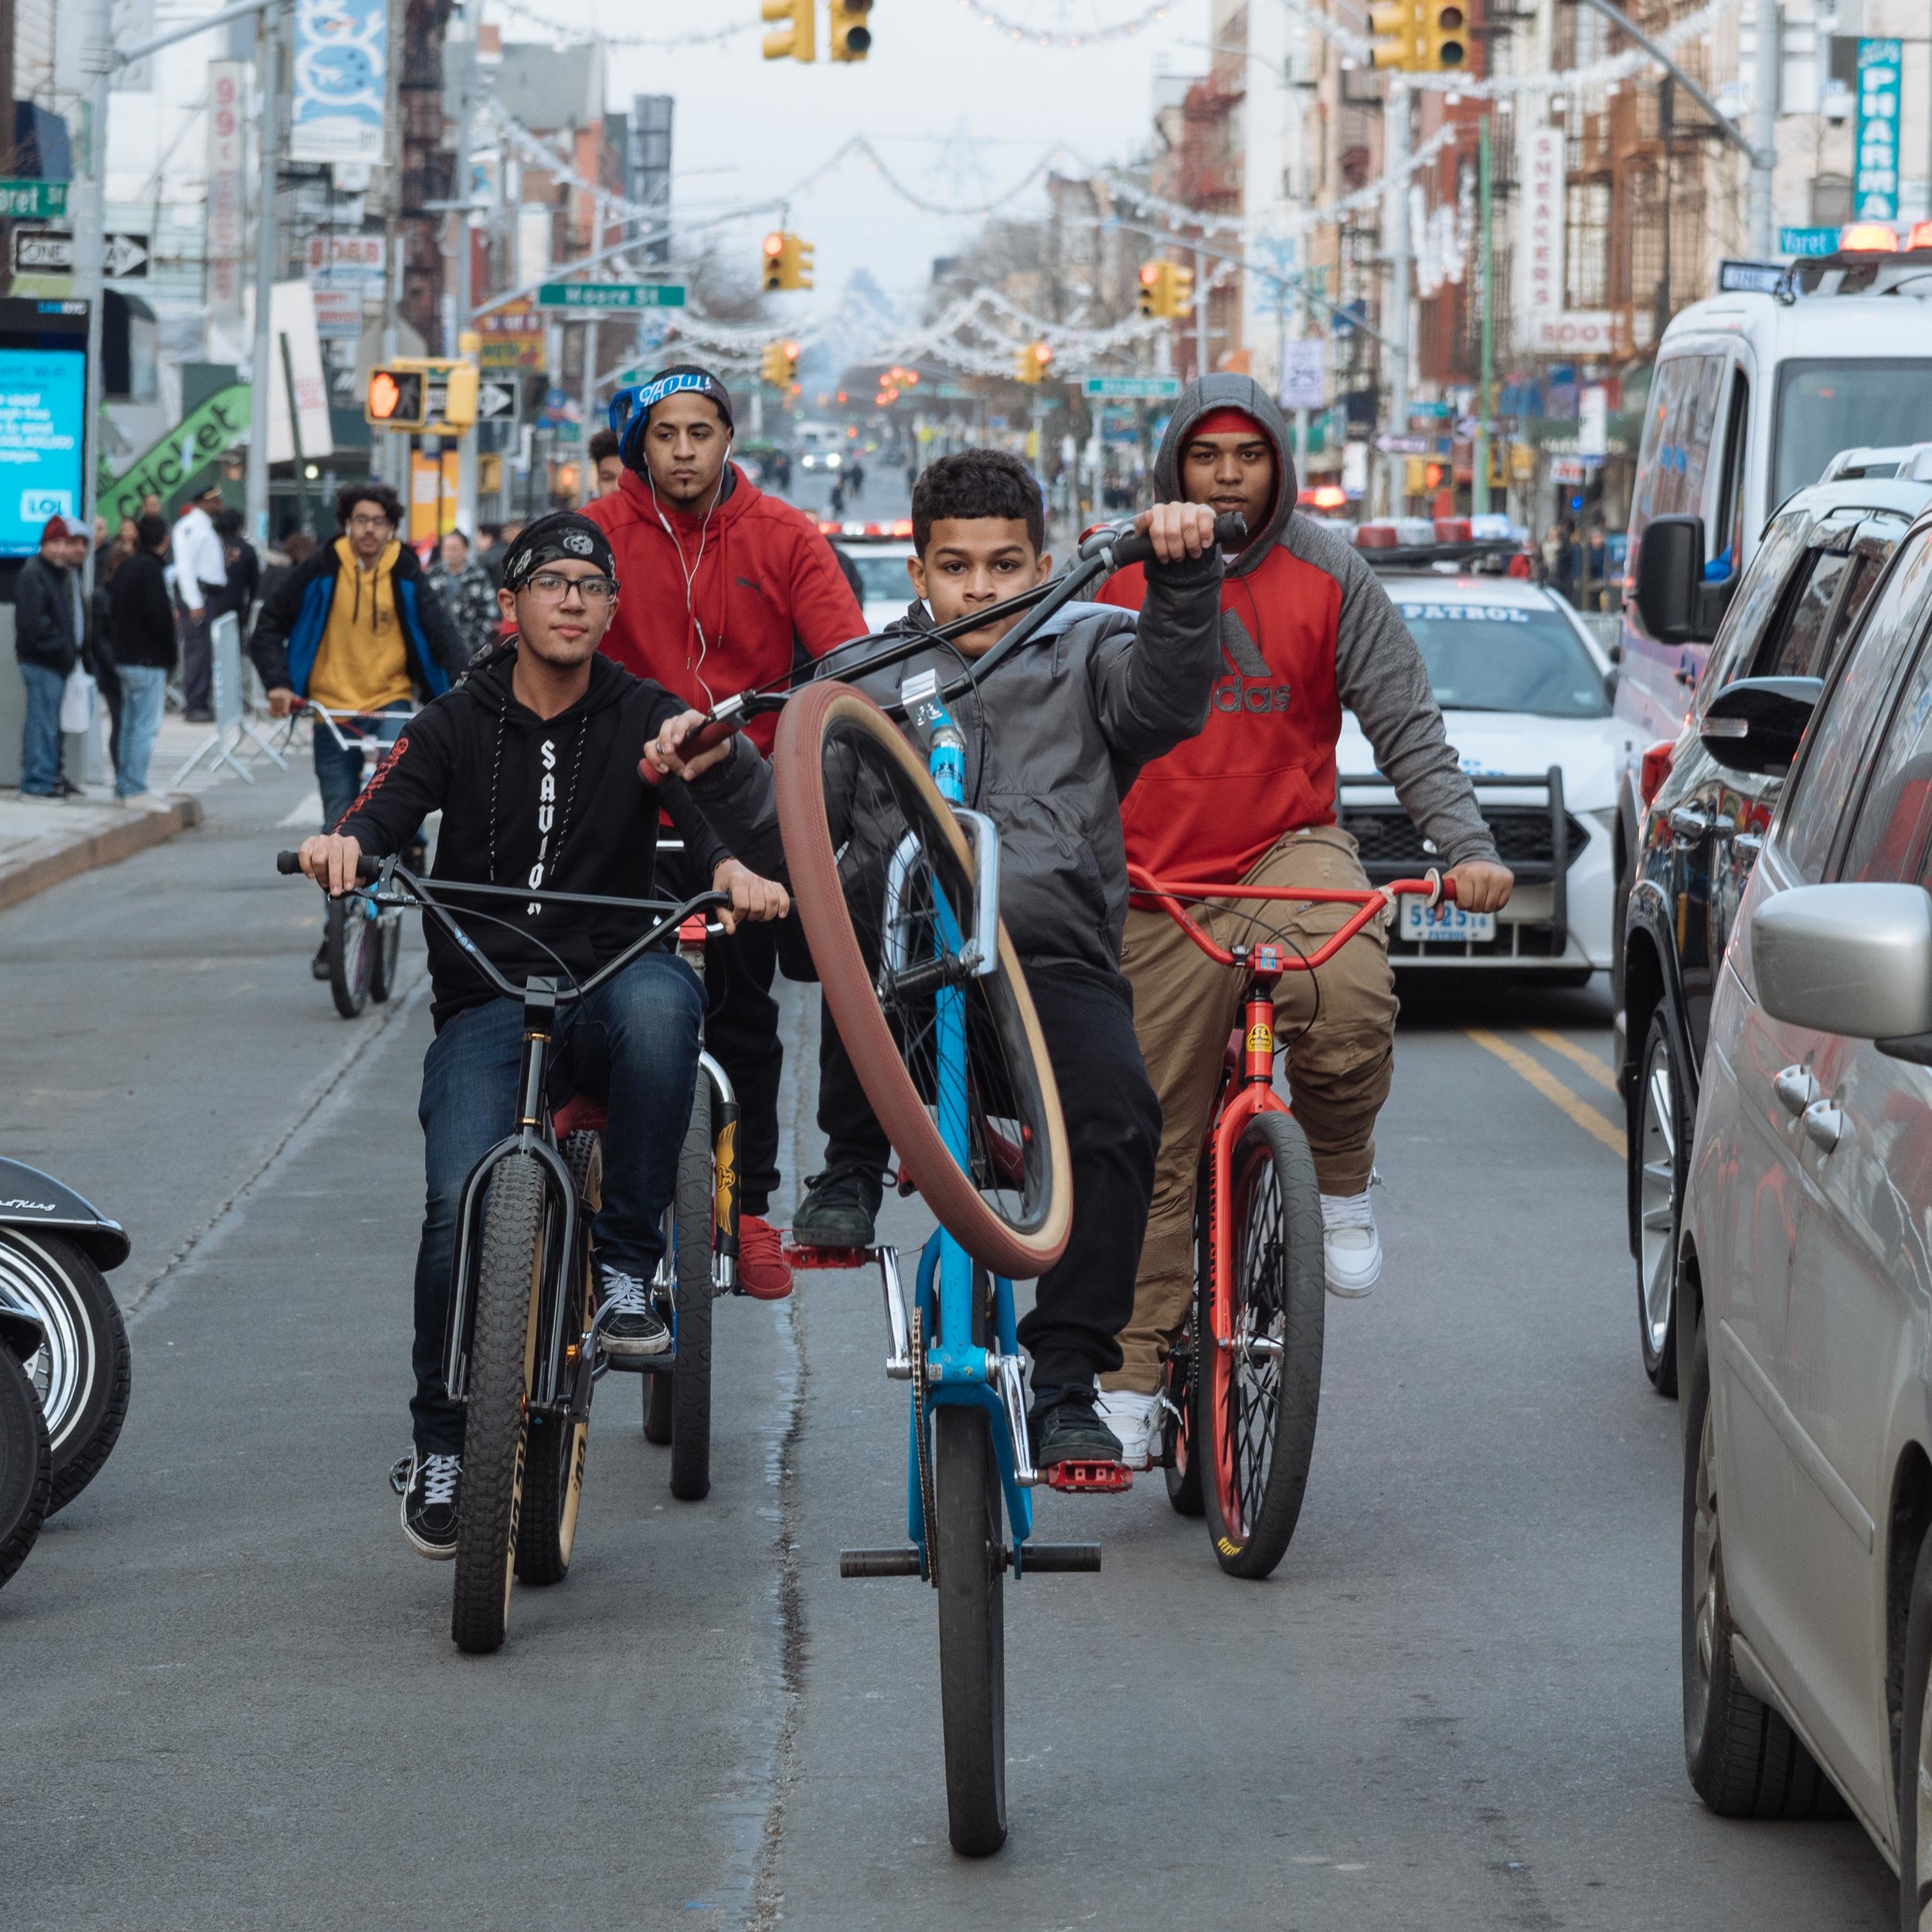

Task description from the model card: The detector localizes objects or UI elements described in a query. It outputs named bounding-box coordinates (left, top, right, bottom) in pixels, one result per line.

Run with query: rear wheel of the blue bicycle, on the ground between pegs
left=930, top=1403, right=1007, bottom=1859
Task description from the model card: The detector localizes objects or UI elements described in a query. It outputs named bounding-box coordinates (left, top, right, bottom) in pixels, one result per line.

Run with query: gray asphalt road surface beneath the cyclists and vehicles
left=0, top=777, right=1892, bottom=1932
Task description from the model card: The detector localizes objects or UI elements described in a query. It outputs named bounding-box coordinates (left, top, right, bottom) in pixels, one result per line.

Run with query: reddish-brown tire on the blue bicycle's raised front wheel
left=775, top=682, right=1073, bottom=1279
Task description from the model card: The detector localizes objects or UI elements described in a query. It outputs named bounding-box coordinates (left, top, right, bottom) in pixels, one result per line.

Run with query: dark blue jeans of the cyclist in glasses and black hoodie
left=410, top=953, right=706, bottom=1455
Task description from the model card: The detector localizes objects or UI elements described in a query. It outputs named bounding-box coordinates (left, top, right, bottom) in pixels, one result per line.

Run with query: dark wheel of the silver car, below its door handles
left=1683, top=1328, right=1847, bottom=1816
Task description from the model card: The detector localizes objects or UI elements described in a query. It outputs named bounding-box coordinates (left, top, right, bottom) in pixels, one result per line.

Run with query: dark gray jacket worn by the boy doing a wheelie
left=692, top=551, right=1221, bottom=972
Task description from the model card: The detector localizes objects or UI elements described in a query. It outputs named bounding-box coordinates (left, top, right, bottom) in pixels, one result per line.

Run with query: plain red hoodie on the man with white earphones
left=583, top=464, right=866, bottom=753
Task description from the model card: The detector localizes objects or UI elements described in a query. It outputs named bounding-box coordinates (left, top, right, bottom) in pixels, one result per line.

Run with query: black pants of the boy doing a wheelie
left=819, top=962, right=1162, bottom=1389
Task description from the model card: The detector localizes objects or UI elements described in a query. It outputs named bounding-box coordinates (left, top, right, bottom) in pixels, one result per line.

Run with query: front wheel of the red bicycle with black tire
left=1194, top=1113, right=1328, bottom=1577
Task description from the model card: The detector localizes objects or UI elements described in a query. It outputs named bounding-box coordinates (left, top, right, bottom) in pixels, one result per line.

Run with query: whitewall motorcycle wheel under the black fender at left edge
left=0, top=1229, right=134, bottom=1517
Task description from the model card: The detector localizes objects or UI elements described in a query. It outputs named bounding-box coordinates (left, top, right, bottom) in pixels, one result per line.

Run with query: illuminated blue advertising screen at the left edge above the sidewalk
left=0, top=298, right=87, bottom=559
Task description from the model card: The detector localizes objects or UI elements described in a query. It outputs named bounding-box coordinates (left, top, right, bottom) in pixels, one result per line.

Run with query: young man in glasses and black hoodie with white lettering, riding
left=287, top=512, right=787, bottom=1557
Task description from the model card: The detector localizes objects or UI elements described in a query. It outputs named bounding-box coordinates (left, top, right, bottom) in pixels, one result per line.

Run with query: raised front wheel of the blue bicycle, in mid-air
left=775, top=682, right=1073, bottom=1279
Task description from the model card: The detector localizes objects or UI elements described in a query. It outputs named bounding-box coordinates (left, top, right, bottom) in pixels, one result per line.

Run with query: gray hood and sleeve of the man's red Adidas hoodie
left=1154, top=375, right=1498, bottom=868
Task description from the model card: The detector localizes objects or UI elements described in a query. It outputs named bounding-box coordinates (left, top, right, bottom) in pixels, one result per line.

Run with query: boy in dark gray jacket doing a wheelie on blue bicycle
left=653, top=451, right=1221, bottom=1468
